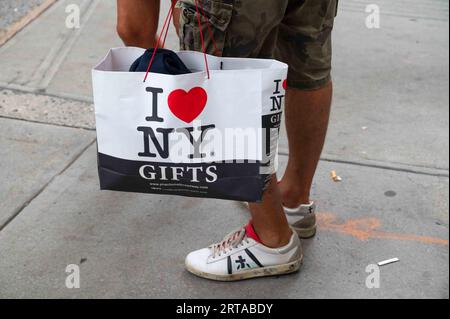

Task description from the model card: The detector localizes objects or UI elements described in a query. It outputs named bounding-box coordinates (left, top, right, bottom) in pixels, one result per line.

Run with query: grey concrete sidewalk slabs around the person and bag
left=0, top=0, right=449, bottom=298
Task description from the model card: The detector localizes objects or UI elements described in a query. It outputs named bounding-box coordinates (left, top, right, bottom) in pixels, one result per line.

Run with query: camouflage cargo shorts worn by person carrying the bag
left=177, top=0, right=338, bottom=89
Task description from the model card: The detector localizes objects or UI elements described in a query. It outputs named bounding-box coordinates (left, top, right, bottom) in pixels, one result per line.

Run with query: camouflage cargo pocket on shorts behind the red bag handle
left=179, top=0, right=233, bottom=55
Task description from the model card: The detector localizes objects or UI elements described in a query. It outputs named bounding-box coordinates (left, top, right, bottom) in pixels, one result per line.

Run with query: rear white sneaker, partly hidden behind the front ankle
left=283, top=202, right=317, bottom=238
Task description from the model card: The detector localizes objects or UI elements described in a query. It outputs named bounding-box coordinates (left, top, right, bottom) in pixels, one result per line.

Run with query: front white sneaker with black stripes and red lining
left=185, top=222, right=303, bottom=281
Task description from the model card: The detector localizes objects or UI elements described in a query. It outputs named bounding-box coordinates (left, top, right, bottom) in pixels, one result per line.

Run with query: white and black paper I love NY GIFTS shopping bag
left=92, top=48, right=287, bottom=201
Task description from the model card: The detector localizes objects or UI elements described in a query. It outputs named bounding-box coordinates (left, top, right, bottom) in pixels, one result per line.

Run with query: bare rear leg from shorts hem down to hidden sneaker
left=279, top=82, right=333, bottom=208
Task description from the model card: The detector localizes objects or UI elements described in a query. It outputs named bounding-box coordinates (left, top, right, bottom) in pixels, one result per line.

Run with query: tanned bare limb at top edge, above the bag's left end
left=117, top=0, right=160, bottom=49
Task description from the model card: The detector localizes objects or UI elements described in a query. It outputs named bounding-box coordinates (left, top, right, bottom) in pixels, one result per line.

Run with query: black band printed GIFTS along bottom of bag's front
left=98, top=153, right=262, bottom=202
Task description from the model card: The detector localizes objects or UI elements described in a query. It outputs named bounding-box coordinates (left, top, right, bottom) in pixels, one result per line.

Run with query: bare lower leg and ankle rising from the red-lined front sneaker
left=250, top=176, right=292, bottom=248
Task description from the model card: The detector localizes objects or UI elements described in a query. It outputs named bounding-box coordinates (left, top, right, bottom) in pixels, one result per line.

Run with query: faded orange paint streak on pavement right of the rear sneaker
left=317, top=213, right=448, bottom=246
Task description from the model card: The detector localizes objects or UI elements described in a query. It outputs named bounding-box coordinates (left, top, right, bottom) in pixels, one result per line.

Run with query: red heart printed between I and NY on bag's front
left=167, top=87, right=208, bottom=123
